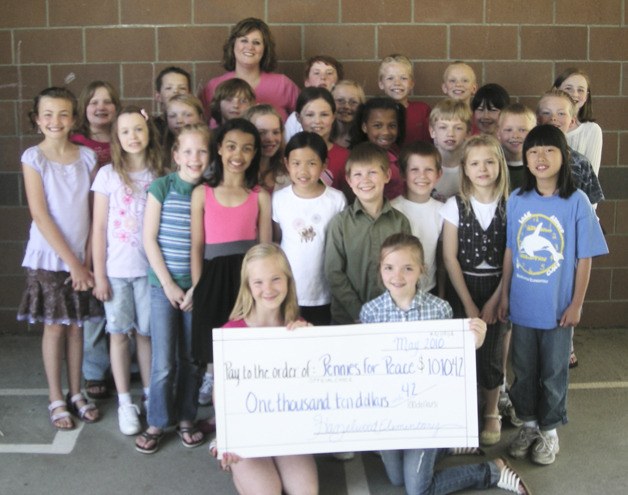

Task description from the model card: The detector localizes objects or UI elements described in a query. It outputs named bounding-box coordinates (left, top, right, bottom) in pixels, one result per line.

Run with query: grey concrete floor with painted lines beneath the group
left=0, top=330, right=628, bottom=495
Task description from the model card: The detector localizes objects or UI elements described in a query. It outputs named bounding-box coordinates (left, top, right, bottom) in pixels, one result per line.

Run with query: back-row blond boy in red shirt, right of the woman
left=379, top=54, right=430, bottom=144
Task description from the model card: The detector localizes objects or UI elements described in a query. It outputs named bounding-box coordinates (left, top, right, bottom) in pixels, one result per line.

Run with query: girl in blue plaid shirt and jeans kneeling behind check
left=360, top=234, right=529, bottom=495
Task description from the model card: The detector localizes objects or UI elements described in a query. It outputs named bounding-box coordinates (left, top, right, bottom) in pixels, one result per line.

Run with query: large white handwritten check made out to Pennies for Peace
left=213, top=320, right=478, bottom=457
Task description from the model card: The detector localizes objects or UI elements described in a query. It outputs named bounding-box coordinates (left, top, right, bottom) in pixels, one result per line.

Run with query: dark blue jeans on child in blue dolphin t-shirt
left=510, top=324, right=573, bottom=431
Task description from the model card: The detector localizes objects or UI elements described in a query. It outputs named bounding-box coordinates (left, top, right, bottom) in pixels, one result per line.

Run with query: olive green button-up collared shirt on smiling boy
left=325, top=199, right=411, bottom=325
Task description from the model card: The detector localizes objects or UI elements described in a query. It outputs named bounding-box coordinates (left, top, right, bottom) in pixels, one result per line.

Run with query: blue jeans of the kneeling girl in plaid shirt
left=382, top=449, right=500, bottom=495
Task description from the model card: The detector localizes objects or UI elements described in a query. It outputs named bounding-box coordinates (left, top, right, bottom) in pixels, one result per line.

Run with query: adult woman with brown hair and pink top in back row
left=201, top=17, right=299, bottom=121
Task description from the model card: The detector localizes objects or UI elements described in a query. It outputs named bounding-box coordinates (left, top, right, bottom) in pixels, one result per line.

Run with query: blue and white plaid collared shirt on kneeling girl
left=360, top=290, right=453, bottom=323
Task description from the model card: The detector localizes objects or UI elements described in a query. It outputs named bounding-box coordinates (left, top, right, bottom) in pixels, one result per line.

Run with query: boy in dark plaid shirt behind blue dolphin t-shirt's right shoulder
left=536, top=88, right=604, bottom=206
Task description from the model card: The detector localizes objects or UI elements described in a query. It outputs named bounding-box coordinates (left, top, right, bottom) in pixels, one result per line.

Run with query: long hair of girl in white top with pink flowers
left=111, top=105, right=164, bottom=188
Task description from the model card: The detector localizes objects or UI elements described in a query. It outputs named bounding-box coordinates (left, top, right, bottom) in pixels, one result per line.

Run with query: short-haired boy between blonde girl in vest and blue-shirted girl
left=497, top=103, right=536, bottom=191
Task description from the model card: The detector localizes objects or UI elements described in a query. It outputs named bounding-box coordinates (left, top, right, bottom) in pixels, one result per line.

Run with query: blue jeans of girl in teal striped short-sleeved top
left=148, top=287, right=201, bottom=428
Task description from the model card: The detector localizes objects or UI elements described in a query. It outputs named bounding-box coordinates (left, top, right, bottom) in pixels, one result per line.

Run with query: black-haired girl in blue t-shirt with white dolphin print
left=498, top=125, right=608, bottom=464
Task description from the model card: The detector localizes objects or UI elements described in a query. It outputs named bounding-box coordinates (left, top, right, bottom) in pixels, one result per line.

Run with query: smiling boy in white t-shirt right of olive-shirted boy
left=391, top=141, right=444, bottom=294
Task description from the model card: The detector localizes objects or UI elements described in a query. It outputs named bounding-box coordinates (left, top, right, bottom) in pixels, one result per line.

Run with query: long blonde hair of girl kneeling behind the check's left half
left=229, top=244, right=299, bottom=323
